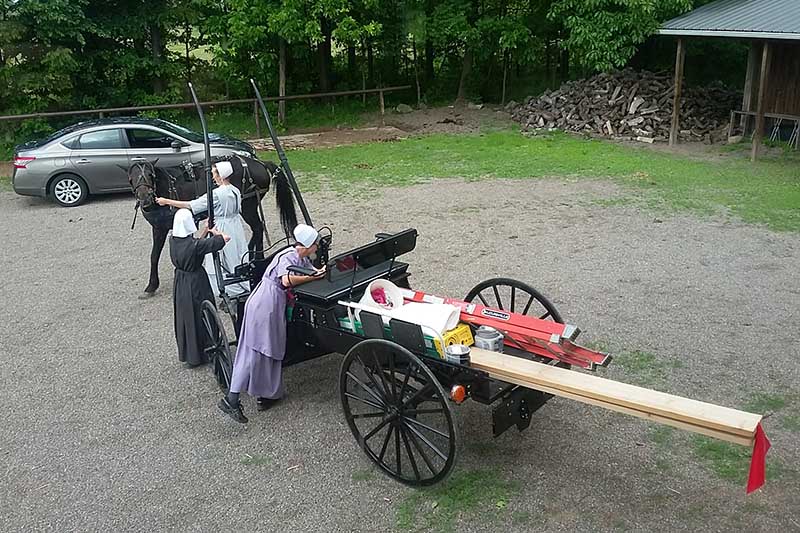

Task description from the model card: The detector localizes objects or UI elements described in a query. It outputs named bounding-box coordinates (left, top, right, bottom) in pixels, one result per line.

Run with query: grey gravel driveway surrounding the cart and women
left=0, top=180, right=800, bottom=532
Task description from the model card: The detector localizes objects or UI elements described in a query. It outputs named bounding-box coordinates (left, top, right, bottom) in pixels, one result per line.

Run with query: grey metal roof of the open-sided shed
left=658, top=0, right=800, bottom=40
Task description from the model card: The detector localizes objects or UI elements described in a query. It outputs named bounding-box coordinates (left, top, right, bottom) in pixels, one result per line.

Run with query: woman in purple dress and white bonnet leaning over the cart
left=218, top=224, right=325, bottom=424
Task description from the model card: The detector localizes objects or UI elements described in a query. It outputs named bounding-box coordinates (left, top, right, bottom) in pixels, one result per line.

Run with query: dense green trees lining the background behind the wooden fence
left=0, top=0, right=744, bottom=114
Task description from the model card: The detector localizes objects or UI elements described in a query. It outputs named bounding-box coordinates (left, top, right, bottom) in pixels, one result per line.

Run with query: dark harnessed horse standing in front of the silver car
left=128, top=155, right=297, bottom=296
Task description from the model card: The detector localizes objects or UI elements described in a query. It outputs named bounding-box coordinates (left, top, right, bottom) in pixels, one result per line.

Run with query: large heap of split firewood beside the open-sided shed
left=506, top=69, right=742, bottom=143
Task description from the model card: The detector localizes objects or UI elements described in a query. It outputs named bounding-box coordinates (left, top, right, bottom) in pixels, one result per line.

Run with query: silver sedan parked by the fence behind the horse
left=12, top=117, right=255, bottom=207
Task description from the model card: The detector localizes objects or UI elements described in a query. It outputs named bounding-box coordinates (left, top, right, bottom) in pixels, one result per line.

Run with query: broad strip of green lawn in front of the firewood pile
left=280, top=130, right=800, bottom=231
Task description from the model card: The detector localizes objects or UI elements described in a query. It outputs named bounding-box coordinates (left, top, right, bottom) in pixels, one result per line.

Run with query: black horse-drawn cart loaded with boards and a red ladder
left=192, top=84, right=769, bottom=490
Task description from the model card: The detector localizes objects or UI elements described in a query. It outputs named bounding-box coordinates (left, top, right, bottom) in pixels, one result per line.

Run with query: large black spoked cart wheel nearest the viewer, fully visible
left=339, top=339, right=456, bottom=486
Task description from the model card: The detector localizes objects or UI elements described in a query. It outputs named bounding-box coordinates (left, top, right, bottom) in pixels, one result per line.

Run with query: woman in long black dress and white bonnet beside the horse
left=169, top=209, right=230, bottom=366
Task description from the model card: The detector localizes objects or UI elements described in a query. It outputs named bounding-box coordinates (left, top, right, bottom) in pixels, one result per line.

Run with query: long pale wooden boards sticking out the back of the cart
left=470, top=346, right=761, bottom=445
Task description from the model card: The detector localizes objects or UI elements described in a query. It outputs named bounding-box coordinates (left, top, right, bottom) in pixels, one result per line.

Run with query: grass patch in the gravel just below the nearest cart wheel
left=396, top=470, right=517, bottom=532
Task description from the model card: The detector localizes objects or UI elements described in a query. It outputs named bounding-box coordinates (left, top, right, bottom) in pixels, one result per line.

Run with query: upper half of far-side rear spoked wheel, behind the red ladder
left=464, top=278, right=564, bottom=324
